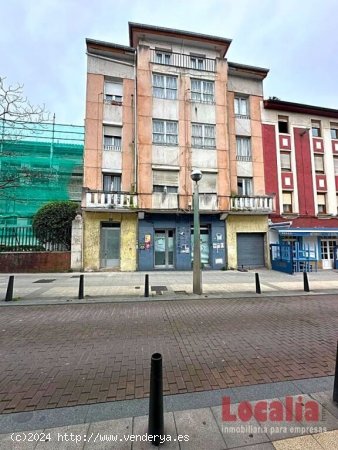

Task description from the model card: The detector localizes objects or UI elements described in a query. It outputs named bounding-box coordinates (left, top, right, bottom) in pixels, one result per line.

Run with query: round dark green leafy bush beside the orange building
left=33, top=200, right=79, bottom=250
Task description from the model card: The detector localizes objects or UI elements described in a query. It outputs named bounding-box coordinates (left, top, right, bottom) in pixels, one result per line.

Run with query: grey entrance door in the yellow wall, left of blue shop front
left=100, top=222, right=121, bottom=268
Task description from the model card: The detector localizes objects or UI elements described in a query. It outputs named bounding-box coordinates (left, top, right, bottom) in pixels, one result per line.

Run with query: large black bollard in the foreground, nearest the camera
left=148, top=353, right=164, bottom=447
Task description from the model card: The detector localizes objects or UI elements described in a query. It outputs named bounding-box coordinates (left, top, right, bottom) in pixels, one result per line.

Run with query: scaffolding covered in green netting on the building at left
left=0, top=120, right=84, bottom=227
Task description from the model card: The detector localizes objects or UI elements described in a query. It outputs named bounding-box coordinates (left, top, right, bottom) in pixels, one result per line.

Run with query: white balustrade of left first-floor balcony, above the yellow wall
left=85, top=191, right=137, bottom=209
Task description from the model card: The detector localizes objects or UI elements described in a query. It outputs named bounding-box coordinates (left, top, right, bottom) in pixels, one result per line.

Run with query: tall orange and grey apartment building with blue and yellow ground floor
left=82, top=23, right=273, bottom=270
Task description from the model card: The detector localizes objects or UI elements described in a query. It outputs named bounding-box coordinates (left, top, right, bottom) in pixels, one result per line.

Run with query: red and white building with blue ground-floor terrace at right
left=262, top=100, right=338, bottom=271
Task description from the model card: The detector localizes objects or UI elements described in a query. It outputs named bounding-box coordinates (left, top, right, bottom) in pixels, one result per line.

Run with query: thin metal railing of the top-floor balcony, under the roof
left=150, top=50, right=216, bottom=72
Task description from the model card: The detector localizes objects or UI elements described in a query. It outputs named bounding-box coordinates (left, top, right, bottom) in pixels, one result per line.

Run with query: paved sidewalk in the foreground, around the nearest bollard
left=0, top=377, right=338, bottom=450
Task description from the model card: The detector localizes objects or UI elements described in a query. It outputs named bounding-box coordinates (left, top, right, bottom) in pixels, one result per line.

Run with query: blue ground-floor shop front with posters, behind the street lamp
left=138, top=212, right=226, bottom=271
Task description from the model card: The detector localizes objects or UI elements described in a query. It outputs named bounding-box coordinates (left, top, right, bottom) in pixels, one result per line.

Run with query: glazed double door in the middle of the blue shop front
left=154, top=230, right=175, bottom=269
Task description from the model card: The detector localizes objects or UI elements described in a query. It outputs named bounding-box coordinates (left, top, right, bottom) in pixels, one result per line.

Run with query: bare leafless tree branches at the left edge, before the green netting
left=0, top=76, right=49, bottom=192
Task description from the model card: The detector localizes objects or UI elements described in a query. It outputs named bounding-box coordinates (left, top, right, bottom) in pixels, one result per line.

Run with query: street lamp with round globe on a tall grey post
left=190, top=169, right=202, bottom=295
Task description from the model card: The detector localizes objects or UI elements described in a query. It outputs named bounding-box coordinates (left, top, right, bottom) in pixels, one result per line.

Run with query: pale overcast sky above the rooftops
left=0, top=0, right=338, bottom=125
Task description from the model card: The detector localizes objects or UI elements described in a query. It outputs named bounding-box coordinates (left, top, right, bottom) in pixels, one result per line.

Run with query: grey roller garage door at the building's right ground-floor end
left=237, top=233, right=265, bottom=268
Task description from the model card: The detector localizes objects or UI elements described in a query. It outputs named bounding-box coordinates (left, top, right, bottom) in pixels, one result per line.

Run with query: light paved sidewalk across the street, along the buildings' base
left=0, top=269, right=338, bottom=306
